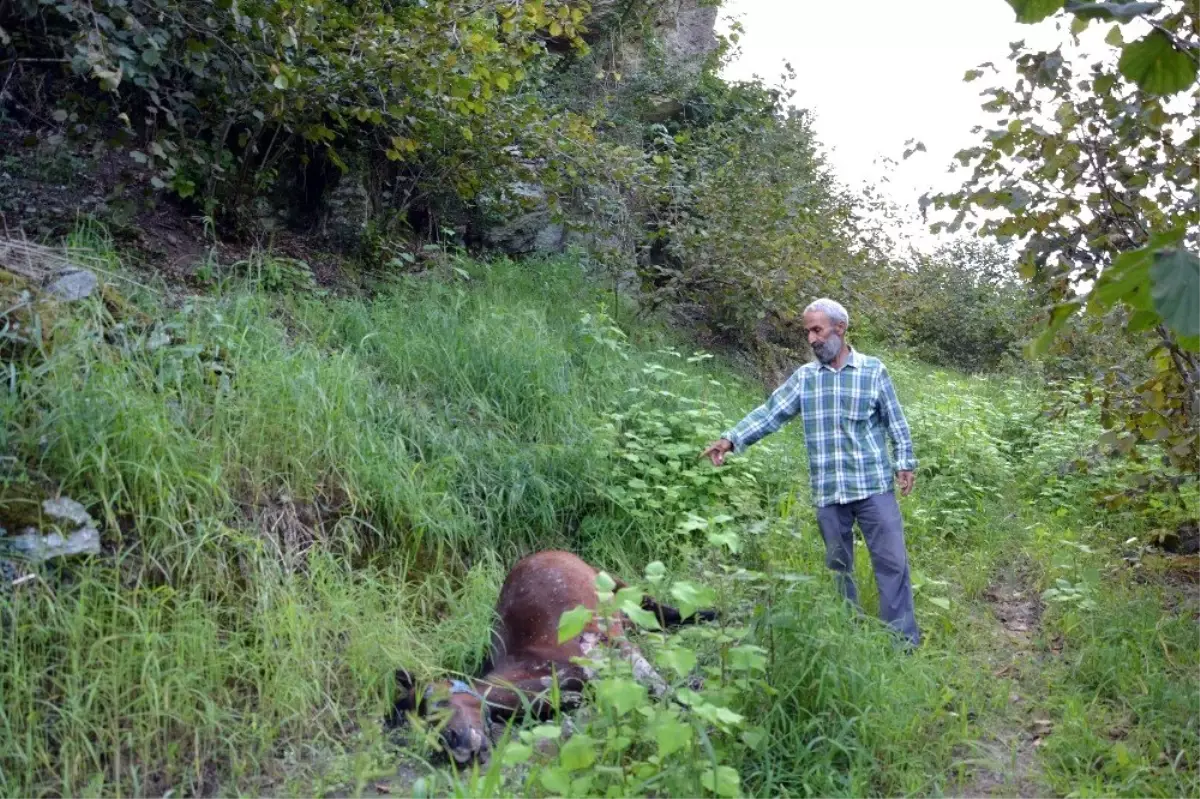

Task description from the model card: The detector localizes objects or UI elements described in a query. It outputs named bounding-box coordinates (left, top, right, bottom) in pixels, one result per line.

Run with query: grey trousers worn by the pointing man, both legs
left=817, top=491, right=920, bottom=645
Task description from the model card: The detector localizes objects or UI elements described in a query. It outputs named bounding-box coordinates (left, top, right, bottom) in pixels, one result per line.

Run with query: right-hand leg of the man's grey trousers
left=857, top=491, right=920, bottom=645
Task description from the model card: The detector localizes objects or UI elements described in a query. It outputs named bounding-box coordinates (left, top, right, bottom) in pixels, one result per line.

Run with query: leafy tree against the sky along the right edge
left=923, top=0, right=1200, bottom=484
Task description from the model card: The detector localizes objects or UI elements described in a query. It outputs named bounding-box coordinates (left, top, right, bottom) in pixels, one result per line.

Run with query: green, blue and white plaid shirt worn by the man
left=722, top=349, right=917, bottom=507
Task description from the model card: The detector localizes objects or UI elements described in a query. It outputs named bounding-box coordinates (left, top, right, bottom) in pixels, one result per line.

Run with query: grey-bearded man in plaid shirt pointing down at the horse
left=701, top=299, right=920, bottom=647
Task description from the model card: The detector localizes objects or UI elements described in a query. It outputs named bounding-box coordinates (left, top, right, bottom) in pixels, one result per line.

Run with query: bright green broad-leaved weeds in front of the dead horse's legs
left=475, top=561, right=772, bottom=797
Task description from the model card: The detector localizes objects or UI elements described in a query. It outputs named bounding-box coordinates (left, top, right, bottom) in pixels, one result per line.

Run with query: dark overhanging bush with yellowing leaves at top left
left=0, top=0, right=587, bottom=222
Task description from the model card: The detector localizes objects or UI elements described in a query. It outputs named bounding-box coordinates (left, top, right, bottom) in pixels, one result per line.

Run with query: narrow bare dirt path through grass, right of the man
left=947, top=567, right=1052, bottom=799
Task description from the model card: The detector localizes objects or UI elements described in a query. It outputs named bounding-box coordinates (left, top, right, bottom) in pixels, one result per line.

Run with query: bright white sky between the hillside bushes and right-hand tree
left=720, top=0, right=1067, bottom=248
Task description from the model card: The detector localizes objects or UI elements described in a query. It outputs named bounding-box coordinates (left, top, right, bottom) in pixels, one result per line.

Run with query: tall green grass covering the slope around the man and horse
left=0, top=226, right=1200, bottom=797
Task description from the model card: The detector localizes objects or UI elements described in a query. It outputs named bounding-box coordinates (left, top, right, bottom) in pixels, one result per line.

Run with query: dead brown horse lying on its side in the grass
left=391, top=549, right=716, bottom=764
